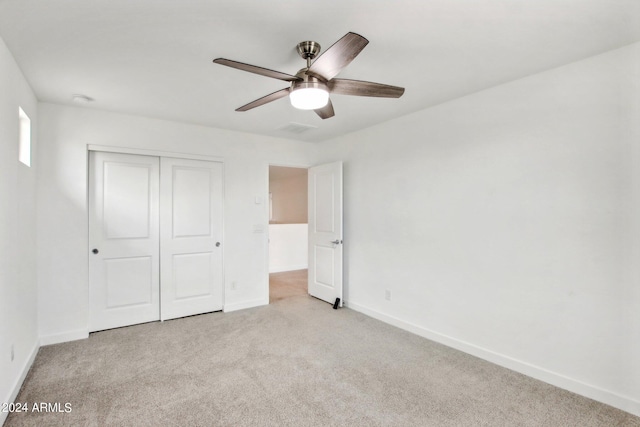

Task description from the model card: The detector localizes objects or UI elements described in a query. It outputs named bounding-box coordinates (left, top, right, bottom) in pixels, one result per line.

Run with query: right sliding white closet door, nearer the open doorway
left=160, top=158, right=223, bottom=320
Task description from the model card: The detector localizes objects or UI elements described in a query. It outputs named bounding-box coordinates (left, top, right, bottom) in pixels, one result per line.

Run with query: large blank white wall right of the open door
left=323, top=44, right=640, bottom=415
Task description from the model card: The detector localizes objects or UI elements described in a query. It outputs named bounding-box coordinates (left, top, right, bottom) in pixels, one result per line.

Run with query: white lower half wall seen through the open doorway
left=269, top=224, right=309, bottom=273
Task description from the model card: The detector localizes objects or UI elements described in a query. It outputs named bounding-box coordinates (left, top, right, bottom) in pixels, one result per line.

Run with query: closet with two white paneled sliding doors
left=89, top=151, right=223, bottom=332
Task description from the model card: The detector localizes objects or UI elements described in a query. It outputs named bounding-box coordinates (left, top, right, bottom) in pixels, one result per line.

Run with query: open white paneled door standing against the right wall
left=308, top=162, right=342, bottom=307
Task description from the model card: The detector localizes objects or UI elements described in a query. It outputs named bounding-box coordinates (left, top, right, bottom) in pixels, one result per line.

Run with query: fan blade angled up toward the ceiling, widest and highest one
left=308, top=33, right=369, bottom=80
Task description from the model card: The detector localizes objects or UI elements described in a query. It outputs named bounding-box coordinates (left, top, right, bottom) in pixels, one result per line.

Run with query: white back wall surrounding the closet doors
left=38, top=104, right=311, bottom=344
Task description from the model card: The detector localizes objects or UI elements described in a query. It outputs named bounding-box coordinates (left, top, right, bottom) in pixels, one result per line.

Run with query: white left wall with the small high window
left=0, top=35, right=38, bottom=424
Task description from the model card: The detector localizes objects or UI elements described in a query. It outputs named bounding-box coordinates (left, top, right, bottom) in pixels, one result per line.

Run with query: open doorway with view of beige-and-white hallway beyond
left=269, top=165, right=308, bottom=303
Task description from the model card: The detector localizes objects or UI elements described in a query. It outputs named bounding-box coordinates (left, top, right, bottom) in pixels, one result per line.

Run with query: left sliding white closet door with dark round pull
left=89, top=152, right=160, bottom=331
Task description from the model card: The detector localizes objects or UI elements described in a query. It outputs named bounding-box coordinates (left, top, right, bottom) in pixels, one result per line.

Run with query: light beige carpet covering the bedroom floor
left=6, top=272, right=640, bottom=427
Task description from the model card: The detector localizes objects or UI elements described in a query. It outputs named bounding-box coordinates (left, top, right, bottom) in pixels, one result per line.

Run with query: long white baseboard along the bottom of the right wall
left=348, top=301, right=640, bottom=416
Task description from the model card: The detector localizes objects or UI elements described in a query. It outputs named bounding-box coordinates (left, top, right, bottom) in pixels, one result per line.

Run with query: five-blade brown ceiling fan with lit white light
left=213, top=33, right=404, bottom=119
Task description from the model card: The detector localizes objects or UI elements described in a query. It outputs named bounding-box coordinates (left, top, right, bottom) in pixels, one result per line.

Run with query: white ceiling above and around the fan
left=0, top=0, right=640, bottom=141
